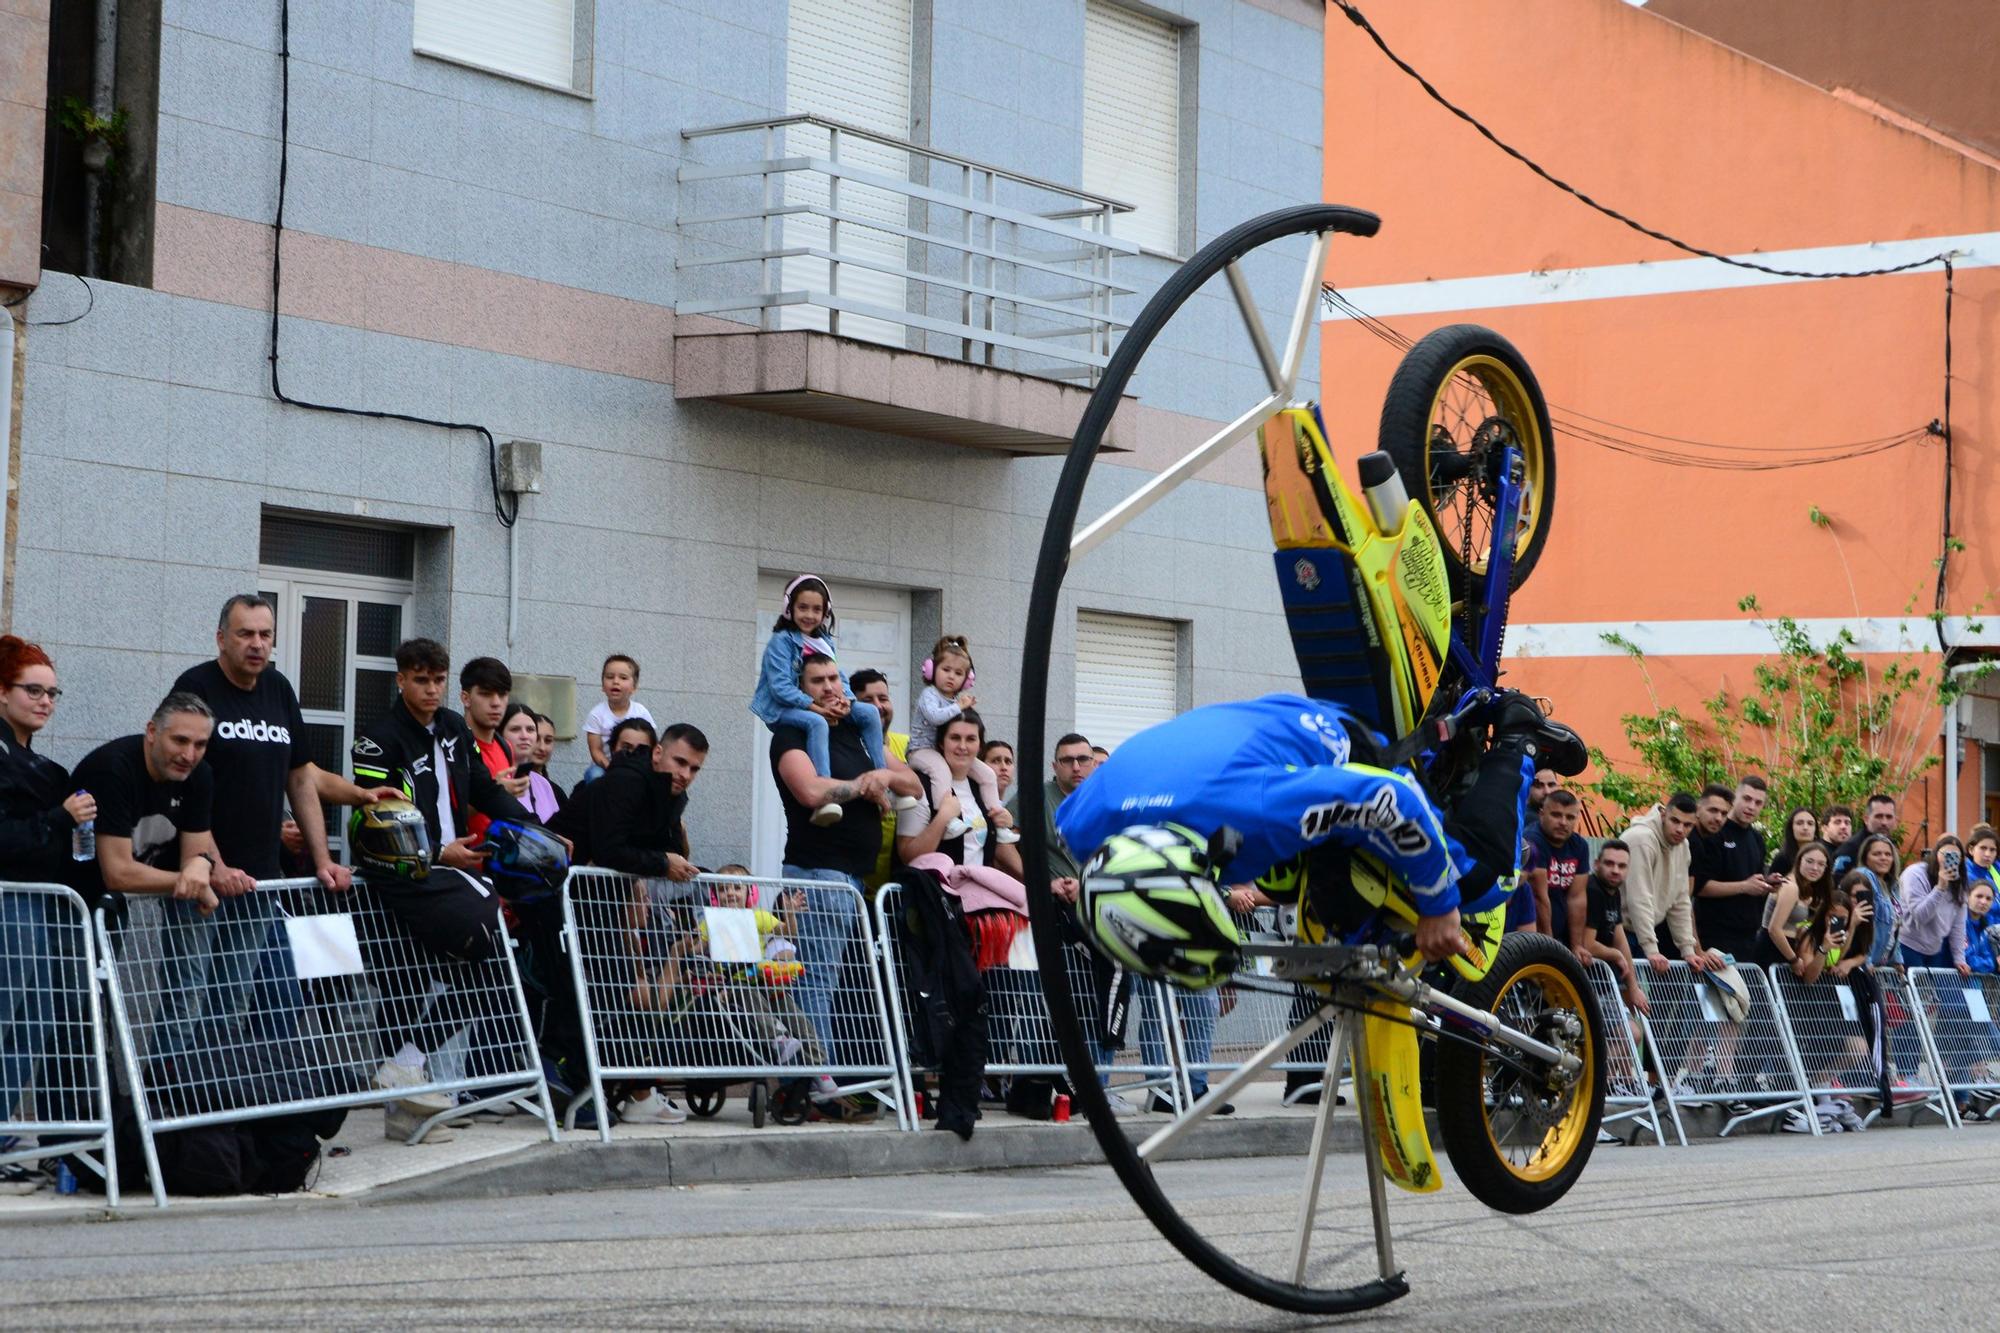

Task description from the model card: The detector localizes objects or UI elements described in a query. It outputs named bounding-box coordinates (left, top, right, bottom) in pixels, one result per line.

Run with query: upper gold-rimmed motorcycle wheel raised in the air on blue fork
left=1378, top=324, right=1556, bottom=598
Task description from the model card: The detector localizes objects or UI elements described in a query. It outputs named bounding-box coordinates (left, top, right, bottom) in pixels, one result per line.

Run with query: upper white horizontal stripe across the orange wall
left=1326, top=232, right=2000, bottom=324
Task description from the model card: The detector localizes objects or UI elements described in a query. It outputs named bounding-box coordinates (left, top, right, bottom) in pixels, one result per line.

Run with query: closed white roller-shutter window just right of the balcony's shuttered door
left=1084, top=0, right=1182, bottom=254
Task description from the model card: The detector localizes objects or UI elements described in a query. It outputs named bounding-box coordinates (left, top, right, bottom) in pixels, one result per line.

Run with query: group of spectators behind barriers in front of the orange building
left=1510, top=771, right=2000, bottom=1133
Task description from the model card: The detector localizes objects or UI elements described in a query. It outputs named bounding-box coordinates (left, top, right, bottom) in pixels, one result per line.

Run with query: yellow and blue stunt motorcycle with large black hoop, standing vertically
left=1020, top=204, right=1606, bottom=1313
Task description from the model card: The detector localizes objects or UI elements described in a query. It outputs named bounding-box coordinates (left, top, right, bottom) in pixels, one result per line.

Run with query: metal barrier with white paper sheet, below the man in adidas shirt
left=98, top=879, right=556, bottom=1207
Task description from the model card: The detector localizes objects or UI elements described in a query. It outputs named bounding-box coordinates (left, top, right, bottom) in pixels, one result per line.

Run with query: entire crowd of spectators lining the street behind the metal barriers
left=0, top=574, right=2000, bottom=1185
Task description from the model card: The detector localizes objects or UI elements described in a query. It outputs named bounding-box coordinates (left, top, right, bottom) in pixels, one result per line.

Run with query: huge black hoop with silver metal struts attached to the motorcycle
left=1020, top=204, right=1424, bottom=1315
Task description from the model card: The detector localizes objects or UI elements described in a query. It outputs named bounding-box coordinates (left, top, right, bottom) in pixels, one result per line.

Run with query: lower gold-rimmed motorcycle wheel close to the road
left=1438, top=935, right=1604, bottom=1213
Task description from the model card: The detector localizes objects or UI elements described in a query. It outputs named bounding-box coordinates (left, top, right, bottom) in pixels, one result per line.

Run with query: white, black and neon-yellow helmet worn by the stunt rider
left=1076, top=825, right=1242, bottom=991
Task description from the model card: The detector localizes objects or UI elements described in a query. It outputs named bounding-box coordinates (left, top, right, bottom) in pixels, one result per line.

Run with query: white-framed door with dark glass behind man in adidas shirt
left=258, top=512, right=416, bottom=857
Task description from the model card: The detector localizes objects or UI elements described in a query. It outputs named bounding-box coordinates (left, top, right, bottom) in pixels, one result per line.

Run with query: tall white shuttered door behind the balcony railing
left=778, top=0, right=914, bottom=346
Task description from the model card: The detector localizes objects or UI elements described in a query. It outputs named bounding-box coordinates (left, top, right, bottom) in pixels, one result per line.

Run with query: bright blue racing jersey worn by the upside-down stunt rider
left=1056, top=695, right=1528, bottom=917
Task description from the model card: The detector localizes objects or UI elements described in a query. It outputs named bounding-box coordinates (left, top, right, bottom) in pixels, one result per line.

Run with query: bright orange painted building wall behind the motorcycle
left=1322, top=0, right=2000, bottom=823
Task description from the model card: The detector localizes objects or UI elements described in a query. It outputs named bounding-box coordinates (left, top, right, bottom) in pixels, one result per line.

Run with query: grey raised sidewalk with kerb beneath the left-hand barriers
left=0, top=1081, right=1360, bottom=1225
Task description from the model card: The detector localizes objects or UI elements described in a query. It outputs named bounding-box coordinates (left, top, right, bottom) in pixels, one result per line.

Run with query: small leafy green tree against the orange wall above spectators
left=1588, top=594, right=2000, bottom=835
